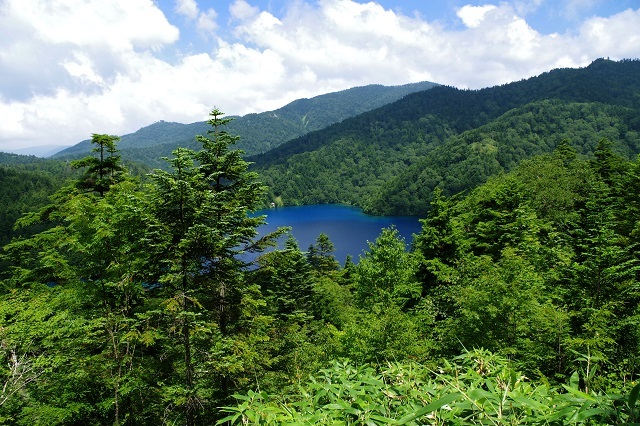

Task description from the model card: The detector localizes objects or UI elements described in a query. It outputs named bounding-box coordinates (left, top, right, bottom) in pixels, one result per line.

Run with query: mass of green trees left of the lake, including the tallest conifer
left=0, top=111, right=290, bottom=424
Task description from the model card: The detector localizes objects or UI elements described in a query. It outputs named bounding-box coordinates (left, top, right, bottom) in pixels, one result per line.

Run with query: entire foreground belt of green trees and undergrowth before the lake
left=0, top=110, right=640, bottom=425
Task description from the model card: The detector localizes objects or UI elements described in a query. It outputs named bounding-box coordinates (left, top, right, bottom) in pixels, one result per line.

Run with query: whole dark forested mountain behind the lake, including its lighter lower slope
left=251, top=59, right=640, bottom=215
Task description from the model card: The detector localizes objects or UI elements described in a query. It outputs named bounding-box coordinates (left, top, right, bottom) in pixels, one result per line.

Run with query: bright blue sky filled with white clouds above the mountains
left=0, top=0, right=640, bottom=151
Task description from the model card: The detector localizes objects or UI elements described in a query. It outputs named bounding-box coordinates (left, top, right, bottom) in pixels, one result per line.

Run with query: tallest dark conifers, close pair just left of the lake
left=149, top=109, right=286, bottom=426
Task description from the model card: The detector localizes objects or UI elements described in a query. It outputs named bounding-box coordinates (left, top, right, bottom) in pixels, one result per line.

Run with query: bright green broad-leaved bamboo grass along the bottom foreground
left=217, top=351, right=638, bottom=425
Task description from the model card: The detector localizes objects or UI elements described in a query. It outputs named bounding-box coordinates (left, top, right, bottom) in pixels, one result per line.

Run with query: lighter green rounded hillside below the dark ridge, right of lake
left=367, top=100, right=640, bottom=215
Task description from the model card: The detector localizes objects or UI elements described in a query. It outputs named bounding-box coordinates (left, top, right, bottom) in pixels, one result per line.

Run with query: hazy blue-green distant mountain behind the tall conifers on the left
left=52, top=82, right=436, bottom=167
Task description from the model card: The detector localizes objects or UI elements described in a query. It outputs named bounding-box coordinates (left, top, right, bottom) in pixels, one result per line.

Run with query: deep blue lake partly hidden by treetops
left=256, top=204, right=421, bottom=264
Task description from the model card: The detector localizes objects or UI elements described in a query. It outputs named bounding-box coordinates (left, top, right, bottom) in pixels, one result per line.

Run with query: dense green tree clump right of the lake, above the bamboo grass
left=414, top=149, right=638, bottom=389
